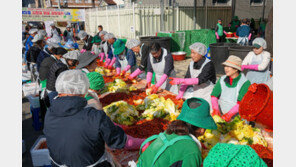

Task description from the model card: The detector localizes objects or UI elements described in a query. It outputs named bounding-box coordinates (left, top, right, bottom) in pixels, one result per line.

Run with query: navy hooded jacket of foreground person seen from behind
left=43, top=96, right=127, bottom=167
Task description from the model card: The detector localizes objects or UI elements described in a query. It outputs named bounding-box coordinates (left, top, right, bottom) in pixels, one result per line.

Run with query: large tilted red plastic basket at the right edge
left=239, top=83, right=273, bottom=129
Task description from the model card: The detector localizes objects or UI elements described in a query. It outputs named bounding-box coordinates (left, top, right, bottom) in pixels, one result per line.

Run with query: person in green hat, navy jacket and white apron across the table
left=113, top=39, right=137, bottom=75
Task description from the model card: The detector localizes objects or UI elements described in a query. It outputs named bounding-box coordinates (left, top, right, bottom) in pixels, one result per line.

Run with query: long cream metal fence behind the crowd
left=85, top=4, right=231, bottom=39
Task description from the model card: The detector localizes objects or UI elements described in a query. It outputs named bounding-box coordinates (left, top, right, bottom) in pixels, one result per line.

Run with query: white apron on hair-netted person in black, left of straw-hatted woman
left=183, top=59, right=214, bottom=108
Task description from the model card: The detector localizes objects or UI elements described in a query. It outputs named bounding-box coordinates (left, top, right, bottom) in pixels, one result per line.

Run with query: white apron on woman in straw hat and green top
left=219, top=73, right=248, bottom=114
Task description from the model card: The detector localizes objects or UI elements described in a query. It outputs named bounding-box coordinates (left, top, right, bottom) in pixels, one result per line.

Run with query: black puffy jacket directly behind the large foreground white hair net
left=46, top=60, right=69, bottom=91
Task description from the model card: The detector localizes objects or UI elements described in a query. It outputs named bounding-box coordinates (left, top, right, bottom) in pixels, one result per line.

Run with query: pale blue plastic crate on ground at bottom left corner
left=30, top=136, right=51, bottom=166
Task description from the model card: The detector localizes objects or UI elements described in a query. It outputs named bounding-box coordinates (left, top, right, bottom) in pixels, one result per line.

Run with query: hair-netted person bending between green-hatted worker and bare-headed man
left=126, top=39, right=149, bottom=80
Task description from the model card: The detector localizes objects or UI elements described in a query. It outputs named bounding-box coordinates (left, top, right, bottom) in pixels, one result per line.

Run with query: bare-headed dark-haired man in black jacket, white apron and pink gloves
left=147, top=42, right=178, bottom=94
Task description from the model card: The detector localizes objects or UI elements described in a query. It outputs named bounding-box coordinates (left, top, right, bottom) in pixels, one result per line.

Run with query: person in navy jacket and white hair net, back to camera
left=43, top=70, right=143, bottom=167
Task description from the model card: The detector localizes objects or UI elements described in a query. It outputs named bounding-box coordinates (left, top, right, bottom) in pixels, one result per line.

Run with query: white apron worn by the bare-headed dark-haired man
left=149, top=48, right=178, bottom=94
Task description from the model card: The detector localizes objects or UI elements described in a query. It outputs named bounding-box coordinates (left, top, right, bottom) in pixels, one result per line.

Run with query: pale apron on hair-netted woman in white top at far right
left=246, top=54, right=270, bottom=84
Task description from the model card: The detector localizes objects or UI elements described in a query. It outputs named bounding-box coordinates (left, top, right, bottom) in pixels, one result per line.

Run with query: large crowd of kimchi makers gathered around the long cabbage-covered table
left=23, top=23, right=270, bottom=167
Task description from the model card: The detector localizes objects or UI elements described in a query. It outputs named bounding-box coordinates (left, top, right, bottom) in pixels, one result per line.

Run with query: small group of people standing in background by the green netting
left=215, top=16, right=266, bottom=45
